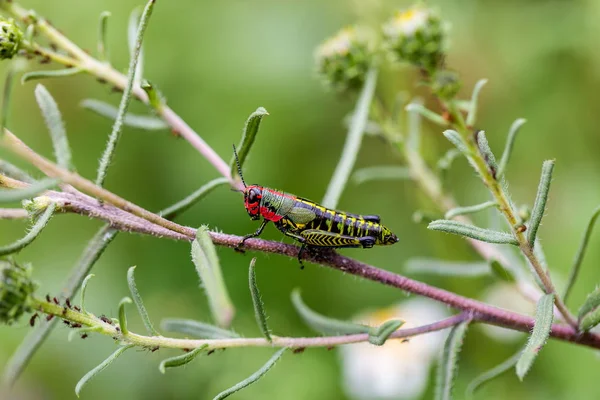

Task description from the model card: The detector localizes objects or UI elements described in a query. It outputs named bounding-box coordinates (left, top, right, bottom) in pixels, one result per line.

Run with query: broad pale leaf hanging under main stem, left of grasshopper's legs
left=192, top=226, right=235, bottom=327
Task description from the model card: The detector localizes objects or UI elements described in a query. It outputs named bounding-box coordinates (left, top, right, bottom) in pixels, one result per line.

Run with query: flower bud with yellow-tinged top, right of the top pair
left=383, top=6, right=445, bottom=74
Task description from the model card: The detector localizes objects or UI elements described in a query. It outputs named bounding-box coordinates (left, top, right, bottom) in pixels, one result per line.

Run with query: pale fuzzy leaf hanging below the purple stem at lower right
left=516, top=293, right=554, bottom=380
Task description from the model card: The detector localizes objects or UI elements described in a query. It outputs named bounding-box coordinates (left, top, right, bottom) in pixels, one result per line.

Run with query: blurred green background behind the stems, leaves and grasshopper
left=0, top=0, right=600, bottom=400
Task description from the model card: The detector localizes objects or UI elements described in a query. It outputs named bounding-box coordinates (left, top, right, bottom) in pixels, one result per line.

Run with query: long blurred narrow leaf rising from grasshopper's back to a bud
left=322, top=69, right=377, bottom=209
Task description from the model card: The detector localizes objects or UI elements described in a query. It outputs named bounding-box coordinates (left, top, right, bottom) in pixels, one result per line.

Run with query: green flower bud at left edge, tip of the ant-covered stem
left=0, top=260, right=37, bottom=325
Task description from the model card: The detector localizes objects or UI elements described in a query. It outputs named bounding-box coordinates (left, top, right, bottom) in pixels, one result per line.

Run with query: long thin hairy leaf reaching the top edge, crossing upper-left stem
left=96, top=0, right=156, bottom=187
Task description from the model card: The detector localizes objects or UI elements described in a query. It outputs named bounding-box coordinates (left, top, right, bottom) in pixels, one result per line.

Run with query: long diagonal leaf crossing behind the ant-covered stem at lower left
left=2, top=225, right=118, bottom=387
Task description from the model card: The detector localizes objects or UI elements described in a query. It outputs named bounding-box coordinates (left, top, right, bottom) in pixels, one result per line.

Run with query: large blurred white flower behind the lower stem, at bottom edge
left=340, top=299, right=448, bottom=400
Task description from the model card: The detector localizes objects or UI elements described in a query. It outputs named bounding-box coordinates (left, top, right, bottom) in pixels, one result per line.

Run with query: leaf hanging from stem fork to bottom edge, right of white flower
left=435, top=321, right=470, bottom=400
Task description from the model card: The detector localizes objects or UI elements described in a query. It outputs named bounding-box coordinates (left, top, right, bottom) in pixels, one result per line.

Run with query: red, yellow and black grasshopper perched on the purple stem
left=233, top=146, right=398, bottom=266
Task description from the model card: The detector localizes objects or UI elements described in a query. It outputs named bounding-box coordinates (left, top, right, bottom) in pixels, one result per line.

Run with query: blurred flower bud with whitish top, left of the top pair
left=315, top=27, right=373, bottom=92
